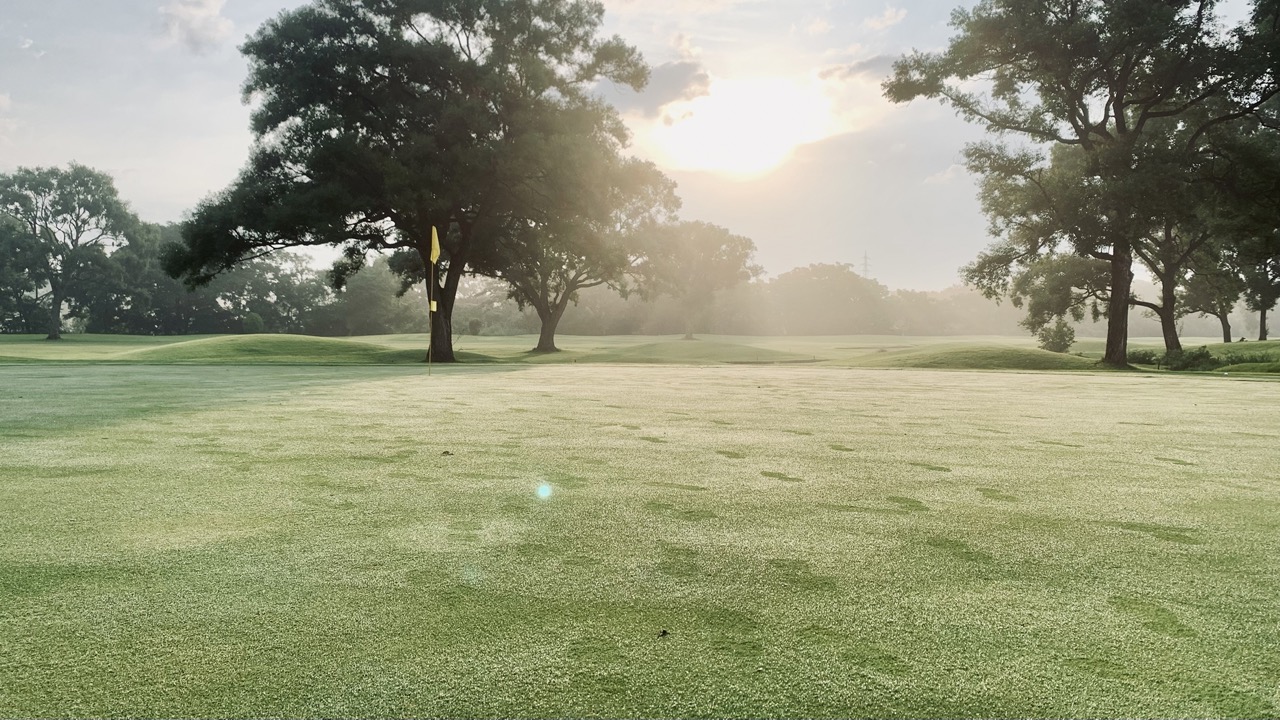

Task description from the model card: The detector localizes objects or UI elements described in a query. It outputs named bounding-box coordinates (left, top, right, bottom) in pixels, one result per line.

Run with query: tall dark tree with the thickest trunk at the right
left=884, top=0, right=1280, bottom=365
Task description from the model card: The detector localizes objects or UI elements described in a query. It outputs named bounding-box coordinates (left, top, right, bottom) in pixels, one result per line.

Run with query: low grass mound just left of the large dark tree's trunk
left=116, top=334, right=422, bottom=365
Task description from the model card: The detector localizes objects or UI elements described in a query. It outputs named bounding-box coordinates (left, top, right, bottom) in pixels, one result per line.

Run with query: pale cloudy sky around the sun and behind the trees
left=0, top=0, right=989, bottom=290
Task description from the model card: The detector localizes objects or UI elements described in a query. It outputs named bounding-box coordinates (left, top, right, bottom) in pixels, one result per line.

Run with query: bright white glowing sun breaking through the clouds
left=646, top=78, right=836, bottom=179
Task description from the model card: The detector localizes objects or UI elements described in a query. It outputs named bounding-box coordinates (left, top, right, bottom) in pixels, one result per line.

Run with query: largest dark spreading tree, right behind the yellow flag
left=166, top=0, right=648, bottom=361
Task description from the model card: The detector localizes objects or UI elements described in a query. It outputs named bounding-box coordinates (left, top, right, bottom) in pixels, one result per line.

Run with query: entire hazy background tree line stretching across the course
left=0, top=165, right=1258, bottom=340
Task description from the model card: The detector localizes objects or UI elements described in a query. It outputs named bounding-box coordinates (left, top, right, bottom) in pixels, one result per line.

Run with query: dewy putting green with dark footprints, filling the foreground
left=0, top=361, right=1280, bottom=717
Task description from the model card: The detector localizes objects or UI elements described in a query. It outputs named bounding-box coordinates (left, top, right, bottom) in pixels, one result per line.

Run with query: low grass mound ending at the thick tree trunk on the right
left=856, top=343, right=1097, bottom=370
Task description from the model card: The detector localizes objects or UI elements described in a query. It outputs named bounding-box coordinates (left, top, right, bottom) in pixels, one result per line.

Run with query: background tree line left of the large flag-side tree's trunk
left=0, top=165, right=426, bottom=338
